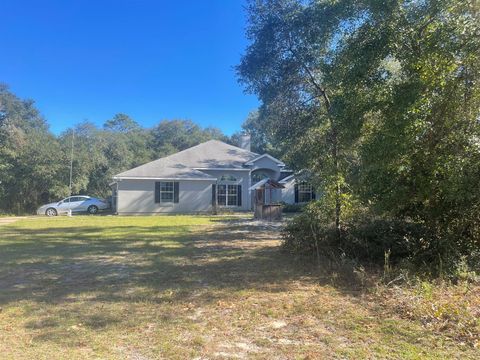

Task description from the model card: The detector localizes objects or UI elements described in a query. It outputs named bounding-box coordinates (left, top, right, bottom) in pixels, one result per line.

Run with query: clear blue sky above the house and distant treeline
left=0, top=0, right=258, bottom=134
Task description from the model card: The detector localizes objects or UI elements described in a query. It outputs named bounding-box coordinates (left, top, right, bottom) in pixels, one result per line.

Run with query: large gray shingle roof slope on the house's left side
left=114, top=140, right=258, bottom=179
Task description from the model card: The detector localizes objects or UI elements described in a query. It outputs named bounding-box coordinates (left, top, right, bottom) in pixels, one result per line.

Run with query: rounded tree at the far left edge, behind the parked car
left=0, top=85, right=67, bottom=213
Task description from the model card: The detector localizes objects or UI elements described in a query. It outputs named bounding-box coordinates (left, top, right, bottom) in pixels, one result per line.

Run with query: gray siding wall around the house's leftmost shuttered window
left=117, top=180, right=213, bottom=215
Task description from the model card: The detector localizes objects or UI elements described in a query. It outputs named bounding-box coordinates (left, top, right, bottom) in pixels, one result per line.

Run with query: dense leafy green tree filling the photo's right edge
left=360, top=0, right=480, bottom=266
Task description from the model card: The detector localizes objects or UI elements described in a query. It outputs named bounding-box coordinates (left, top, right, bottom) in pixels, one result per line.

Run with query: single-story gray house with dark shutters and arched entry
left=111, top=137, right=315, bottom=214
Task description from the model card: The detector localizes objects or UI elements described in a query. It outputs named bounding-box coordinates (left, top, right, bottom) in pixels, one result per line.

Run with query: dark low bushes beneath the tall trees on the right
left=283, top=201, right=480, bottom=278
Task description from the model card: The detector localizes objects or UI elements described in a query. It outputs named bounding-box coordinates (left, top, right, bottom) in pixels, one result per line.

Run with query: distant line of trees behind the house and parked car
left=0, top=84, right=256, bottom=214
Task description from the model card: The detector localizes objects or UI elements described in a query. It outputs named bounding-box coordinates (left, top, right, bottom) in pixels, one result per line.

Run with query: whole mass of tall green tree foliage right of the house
left=242, top=0, right=480, bottom=273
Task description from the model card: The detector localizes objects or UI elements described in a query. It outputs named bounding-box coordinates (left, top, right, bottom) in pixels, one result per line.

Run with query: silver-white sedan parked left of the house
left=37, top=195, right=110, bottom=216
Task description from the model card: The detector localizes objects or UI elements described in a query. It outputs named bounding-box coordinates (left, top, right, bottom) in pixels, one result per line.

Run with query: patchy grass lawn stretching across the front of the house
left=0, top=216, right=478, bottom=359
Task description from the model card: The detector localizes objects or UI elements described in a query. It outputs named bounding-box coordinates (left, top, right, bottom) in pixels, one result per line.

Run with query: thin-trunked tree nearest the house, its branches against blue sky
left=237, top=0, right=373, bottom=236
